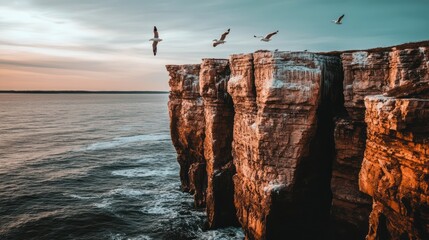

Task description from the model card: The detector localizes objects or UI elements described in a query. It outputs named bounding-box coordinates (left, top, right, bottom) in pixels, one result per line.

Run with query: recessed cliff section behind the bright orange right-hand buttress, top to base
left=331, top=43, right=429, bottom=239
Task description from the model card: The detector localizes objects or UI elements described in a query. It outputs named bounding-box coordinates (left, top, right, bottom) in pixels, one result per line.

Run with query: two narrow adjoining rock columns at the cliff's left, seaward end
left=167, top=59, right=237, bottom=228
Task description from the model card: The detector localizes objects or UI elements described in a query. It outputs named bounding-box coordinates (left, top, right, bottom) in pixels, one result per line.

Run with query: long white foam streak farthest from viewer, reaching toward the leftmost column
left=82, top=134, right=170, bottom=151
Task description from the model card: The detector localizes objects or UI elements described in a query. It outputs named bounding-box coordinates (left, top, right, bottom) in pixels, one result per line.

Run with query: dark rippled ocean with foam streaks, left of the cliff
left=0, top=94, right=244, bottom=240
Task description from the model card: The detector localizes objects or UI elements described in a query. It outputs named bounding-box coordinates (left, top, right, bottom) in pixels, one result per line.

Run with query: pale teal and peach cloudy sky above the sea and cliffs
left=0, top=0, right=429, bottom=91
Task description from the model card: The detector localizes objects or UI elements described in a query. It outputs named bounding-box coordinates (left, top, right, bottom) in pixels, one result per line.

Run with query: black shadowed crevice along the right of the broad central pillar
left=266, top=59, right=347, bottom=239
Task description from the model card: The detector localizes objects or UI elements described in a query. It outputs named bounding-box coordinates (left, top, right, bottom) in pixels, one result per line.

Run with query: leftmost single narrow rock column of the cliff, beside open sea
left=167, top=65, right=207, bottom=207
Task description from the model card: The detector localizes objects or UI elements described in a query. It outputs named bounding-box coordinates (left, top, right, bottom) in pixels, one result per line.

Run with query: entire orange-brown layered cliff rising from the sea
left=167, top=42, right=429, bottom=239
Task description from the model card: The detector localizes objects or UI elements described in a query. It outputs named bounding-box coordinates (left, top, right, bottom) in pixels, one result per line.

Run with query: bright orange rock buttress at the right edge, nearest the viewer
left=359, top=96, right=429, bottom=239
